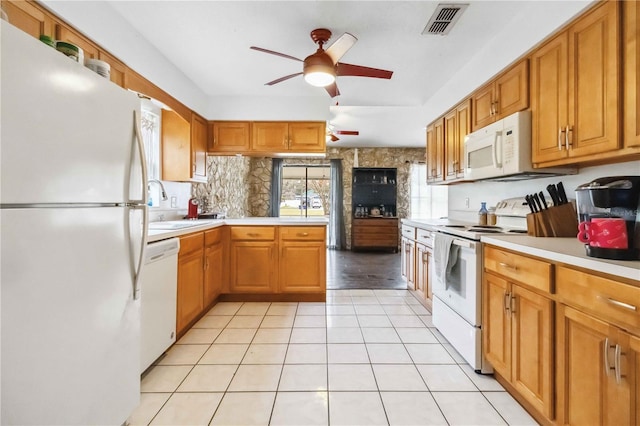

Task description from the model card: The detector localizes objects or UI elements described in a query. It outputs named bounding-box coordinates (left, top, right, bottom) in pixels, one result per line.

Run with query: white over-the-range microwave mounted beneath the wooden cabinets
left=464, top=111, right=578, bottom=181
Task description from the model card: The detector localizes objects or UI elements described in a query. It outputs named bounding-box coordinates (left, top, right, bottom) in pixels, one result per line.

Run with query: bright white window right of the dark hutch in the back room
left=409, top=164, right=449, bottom=219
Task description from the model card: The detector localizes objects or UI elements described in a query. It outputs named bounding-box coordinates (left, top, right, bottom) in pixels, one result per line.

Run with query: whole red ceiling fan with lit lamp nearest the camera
left=250, top=28, right=393, bottom=98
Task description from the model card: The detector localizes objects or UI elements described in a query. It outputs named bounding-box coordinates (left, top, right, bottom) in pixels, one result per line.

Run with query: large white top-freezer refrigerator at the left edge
left=0, top=21, right=147, bottom=425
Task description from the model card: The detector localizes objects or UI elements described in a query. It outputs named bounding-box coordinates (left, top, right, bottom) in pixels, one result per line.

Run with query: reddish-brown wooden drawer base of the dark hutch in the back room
left=351, top=218, right=398, bottom=252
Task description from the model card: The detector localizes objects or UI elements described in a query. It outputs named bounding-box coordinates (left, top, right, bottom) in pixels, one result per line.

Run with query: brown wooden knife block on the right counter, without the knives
left=527, top=203, right=578, bottom=237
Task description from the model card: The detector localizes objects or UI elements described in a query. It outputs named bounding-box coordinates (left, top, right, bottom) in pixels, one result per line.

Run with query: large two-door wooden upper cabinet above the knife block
left=531, top=1, right=624, bottom=166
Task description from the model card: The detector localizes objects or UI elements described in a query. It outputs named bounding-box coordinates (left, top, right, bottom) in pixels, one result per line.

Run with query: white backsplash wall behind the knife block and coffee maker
left=449, top=161, right=640, bottom=222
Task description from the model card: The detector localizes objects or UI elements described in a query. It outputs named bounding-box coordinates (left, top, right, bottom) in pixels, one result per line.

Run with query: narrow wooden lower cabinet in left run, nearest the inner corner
left=204, top=228, right=225, bottom=308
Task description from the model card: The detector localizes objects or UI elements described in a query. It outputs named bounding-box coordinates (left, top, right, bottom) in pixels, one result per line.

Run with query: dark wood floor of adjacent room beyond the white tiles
left=327, top=250, right=407, bottom=290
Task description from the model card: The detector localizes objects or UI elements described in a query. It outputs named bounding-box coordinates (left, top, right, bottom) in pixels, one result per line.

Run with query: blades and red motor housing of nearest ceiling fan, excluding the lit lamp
left=250, top=28, right=393, bottom=98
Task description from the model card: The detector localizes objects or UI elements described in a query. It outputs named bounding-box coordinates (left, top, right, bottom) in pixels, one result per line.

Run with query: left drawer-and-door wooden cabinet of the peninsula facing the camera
left=229, top=226, right=278, bottom=293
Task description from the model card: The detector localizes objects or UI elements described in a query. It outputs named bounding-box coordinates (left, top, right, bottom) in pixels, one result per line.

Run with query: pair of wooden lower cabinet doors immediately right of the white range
left=483, top=273, right=554, bottom=420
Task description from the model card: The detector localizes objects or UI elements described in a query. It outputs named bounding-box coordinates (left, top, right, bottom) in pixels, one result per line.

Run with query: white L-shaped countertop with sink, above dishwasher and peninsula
left=147, top=217, right=329, bottom=243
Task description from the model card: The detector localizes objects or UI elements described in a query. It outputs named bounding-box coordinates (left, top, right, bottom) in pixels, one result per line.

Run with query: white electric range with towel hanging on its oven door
left=432, top=198, right=530, bottom=373
